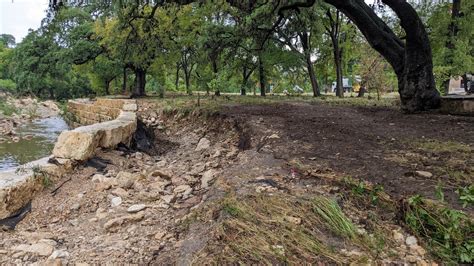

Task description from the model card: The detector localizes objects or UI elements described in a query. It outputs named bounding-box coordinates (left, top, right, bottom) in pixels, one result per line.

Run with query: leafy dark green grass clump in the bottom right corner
left=403, top=195, right=474, bottom=263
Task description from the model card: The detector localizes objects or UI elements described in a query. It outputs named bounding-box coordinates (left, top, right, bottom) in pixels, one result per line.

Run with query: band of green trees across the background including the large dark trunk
left=0, top=0, right=473, bottom=111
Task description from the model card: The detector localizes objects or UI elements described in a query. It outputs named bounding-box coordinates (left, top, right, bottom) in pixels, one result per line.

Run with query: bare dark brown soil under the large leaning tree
left=220, top=104, right=474, bottom=209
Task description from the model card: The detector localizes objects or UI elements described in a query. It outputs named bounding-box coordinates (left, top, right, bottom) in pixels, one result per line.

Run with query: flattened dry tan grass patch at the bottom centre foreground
left=201, top=193, right=343, bottom=265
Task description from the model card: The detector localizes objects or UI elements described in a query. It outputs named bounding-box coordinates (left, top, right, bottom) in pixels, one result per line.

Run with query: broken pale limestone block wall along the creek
left=0, top=99, right=137, bottom=219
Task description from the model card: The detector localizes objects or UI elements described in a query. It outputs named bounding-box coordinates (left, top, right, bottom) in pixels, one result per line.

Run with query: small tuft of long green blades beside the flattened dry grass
left=313, top=196, right=356, bottom=239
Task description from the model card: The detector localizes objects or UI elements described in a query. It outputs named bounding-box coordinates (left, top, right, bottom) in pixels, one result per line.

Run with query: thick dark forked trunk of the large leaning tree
left=325, top=0, right=440, bottom=112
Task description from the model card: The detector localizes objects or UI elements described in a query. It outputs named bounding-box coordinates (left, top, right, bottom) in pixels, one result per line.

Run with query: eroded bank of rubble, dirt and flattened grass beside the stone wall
left=0, top=101, right=474, bottom=265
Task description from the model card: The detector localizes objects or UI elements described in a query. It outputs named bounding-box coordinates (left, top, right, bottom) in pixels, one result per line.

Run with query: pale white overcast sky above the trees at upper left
left=0, top=0, right=49, bottom=43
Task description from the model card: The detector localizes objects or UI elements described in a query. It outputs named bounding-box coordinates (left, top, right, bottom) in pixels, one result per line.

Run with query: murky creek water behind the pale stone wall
left=0, top=117, right=68, bottom=171
